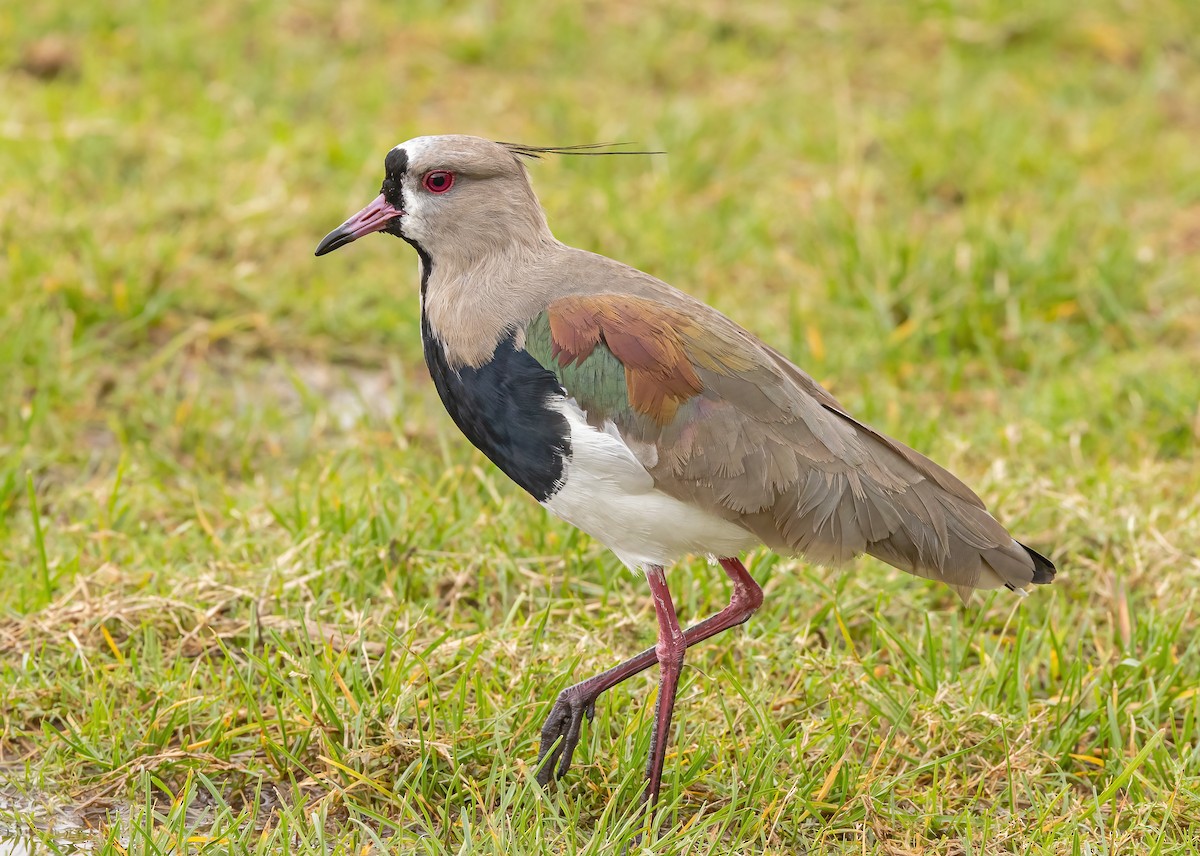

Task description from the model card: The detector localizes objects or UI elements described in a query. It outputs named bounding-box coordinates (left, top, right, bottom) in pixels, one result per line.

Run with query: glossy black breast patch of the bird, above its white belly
left=421, top=313, right=571, bottom=502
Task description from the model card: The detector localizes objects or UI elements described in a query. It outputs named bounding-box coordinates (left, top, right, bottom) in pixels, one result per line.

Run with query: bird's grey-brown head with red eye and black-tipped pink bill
left=317, top=136, right=553, bottom=263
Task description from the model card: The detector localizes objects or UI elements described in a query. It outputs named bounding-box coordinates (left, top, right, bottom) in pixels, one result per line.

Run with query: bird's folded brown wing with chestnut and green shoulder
left=524, top=289, right=1054, bottom=593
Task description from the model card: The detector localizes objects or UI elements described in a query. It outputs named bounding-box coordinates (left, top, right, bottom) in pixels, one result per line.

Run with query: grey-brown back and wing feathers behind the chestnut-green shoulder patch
left=530, top=249, right=1054, bottom=594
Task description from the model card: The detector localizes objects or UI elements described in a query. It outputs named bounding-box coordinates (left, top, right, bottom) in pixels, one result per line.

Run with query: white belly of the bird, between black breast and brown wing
left=542, top=399, right=758, bottom=568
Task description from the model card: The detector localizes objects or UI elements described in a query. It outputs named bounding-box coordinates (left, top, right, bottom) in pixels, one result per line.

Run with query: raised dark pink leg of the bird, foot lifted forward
left=538, top=558, right=762, bottom=795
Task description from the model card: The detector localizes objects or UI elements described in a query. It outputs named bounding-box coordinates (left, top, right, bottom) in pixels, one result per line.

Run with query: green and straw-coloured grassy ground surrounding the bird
left=0, top=0, right=1200, bottom=854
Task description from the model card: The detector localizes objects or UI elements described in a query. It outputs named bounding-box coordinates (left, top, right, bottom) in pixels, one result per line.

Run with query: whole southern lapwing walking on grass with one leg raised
left=317, top=136, right=1055, bottom=812
